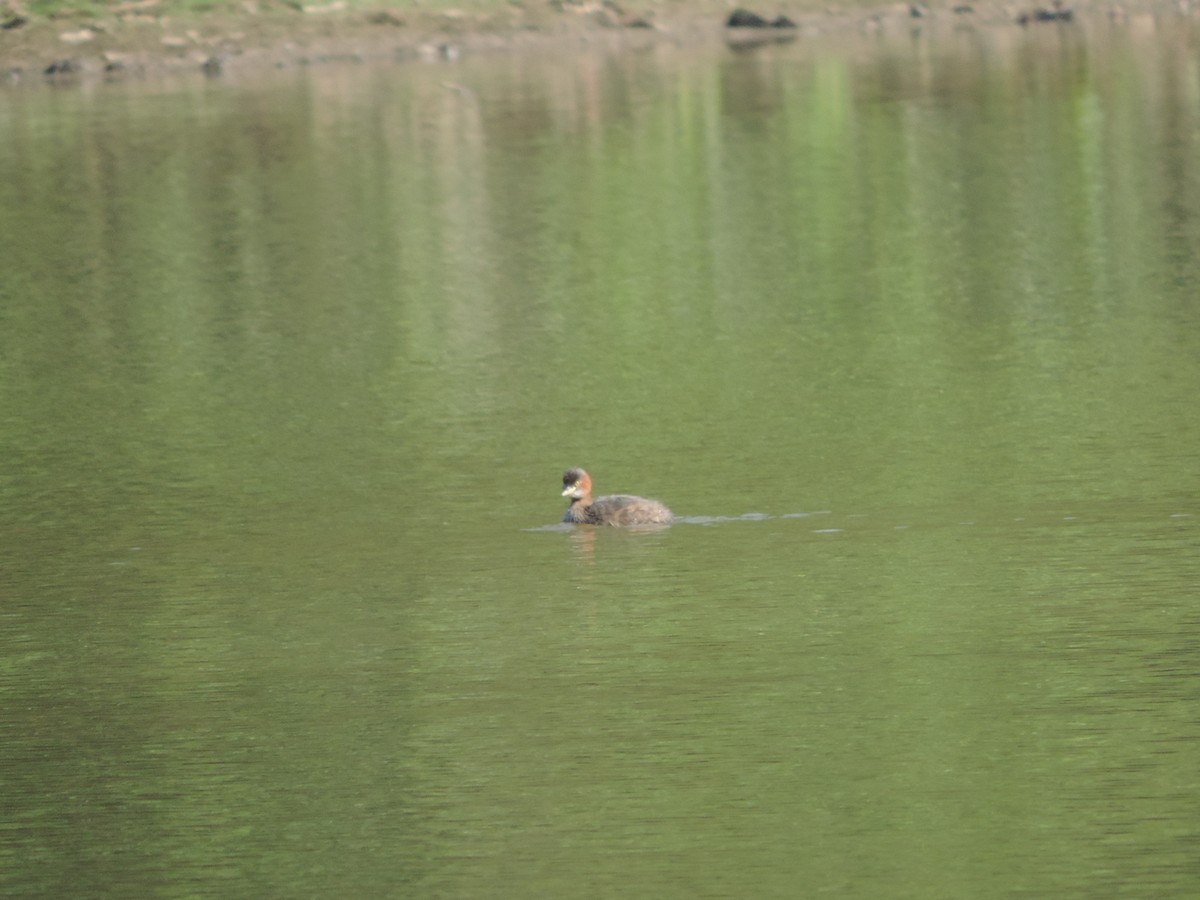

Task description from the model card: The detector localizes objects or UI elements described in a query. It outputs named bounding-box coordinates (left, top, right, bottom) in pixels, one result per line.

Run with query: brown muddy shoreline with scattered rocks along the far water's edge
left=0, top=0, right=1200, bottom=86
